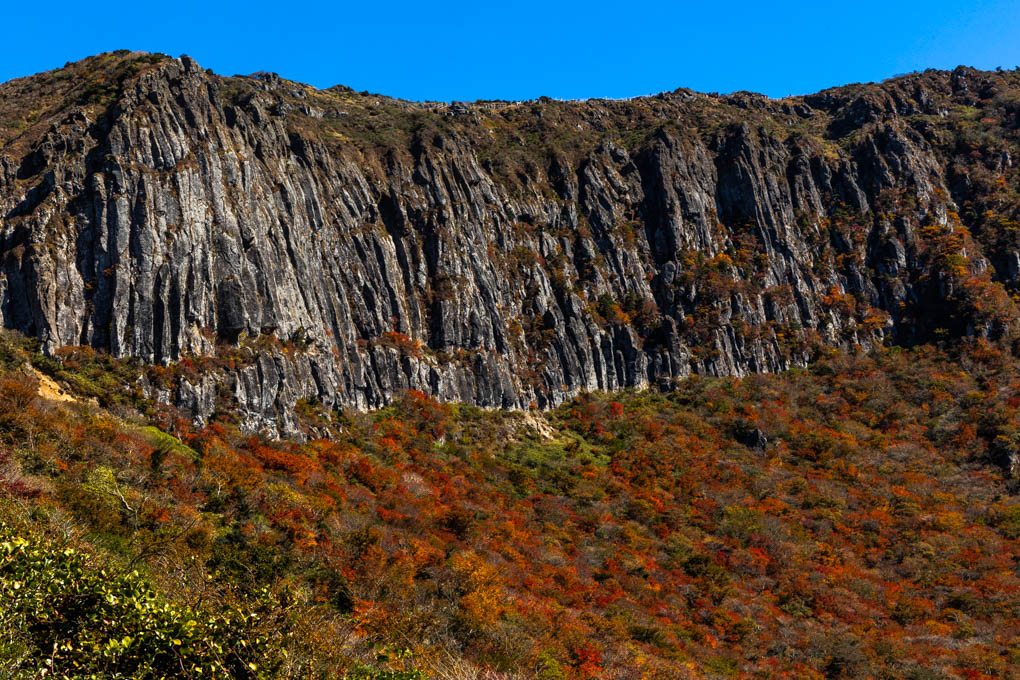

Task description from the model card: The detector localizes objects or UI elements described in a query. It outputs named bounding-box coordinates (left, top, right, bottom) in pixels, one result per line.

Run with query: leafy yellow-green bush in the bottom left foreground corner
left=0, top=525, right=284, bottom=680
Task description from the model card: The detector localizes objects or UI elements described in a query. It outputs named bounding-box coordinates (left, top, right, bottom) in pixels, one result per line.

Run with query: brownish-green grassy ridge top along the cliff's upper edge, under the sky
left=0, top=50, right=1020, bottom=170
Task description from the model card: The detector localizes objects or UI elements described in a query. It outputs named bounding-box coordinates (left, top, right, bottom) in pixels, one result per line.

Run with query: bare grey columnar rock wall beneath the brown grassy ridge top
left=0, top=58, right=1015, bottom=429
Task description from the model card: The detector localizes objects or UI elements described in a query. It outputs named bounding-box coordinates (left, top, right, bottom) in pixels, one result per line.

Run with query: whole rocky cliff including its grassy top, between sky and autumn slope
left=0, top=53, right=1020, bottom=436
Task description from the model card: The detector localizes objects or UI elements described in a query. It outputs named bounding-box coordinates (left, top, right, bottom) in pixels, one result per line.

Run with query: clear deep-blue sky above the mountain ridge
left=0, top=0, right=1020, bottom=100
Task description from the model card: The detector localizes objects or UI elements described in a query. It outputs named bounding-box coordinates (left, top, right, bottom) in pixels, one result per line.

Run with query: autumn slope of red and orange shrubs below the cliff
left=0, top=334, right=1020, bottom=680
